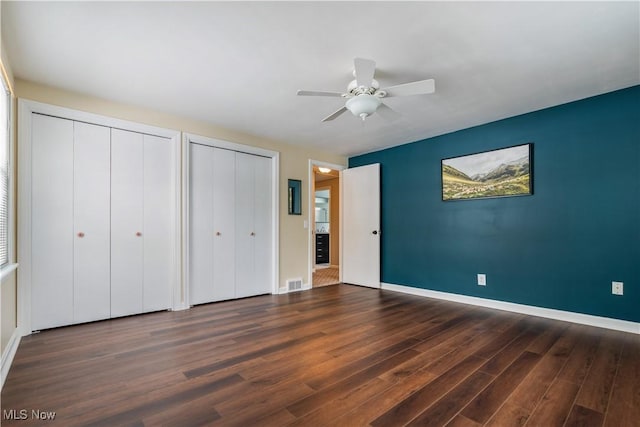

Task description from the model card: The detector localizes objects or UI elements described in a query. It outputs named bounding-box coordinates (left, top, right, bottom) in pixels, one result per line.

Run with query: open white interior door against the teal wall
left=340, top=163, right=380, bottom=288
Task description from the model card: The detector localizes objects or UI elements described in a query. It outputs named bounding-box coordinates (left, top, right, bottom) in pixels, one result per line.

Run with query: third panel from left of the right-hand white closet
left=235, top=153, right=256, bottom=298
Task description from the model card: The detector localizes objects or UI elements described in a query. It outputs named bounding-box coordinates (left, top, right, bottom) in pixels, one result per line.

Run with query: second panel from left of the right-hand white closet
left=211, top=148, right=236, bottom=301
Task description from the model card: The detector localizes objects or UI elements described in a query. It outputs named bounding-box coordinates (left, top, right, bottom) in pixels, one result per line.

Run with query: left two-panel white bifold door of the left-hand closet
left=31, top=114, right=110, bottom=330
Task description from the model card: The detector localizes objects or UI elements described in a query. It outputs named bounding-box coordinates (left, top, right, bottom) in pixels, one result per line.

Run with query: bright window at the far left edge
left=0, top=76, right=11, bottom=266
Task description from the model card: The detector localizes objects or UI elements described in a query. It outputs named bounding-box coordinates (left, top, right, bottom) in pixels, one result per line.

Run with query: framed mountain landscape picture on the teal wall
left=441, top=144, right=533, bottom=201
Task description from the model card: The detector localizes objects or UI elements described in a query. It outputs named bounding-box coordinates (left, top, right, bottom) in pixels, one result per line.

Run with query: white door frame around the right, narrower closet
left=181, top=133, right=280, bottom=308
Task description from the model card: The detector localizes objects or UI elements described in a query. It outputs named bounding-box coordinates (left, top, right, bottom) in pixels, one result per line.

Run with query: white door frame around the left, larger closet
left=17, top=98, right=181, bottom=336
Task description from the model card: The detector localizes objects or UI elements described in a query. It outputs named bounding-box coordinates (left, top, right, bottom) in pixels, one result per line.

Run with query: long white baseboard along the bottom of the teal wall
left=381, top=283, right=640, bottom=334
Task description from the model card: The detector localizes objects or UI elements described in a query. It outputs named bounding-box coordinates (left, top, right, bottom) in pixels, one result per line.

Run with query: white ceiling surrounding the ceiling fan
left=2, top=1, right=640, bottom=155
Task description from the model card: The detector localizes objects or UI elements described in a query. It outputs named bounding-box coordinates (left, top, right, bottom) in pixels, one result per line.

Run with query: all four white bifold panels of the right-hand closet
left=189, top=143, right=272, bottom=304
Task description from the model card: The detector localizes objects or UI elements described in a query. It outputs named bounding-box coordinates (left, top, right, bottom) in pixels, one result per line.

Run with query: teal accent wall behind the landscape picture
left=349, top=86, right=640, bottom=322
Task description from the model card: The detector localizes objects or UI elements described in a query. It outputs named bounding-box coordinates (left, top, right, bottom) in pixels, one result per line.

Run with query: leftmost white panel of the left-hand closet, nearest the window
left=31, top=114, right=74, bottom=330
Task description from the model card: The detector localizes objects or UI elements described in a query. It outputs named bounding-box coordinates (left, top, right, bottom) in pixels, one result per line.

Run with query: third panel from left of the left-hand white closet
left=111, top=129, right=144, bottom=317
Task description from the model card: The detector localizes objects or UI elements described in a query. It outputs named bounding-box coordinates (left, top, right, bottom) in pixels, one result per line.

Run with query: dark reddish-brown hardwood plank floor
left=1, top=285, right=640, bottom=427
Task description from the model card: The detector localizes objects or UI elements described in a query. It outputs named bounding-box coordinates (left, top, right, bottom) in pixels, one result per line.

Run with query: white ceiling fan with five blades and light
left=298, top=58, right=435, bottom=122
